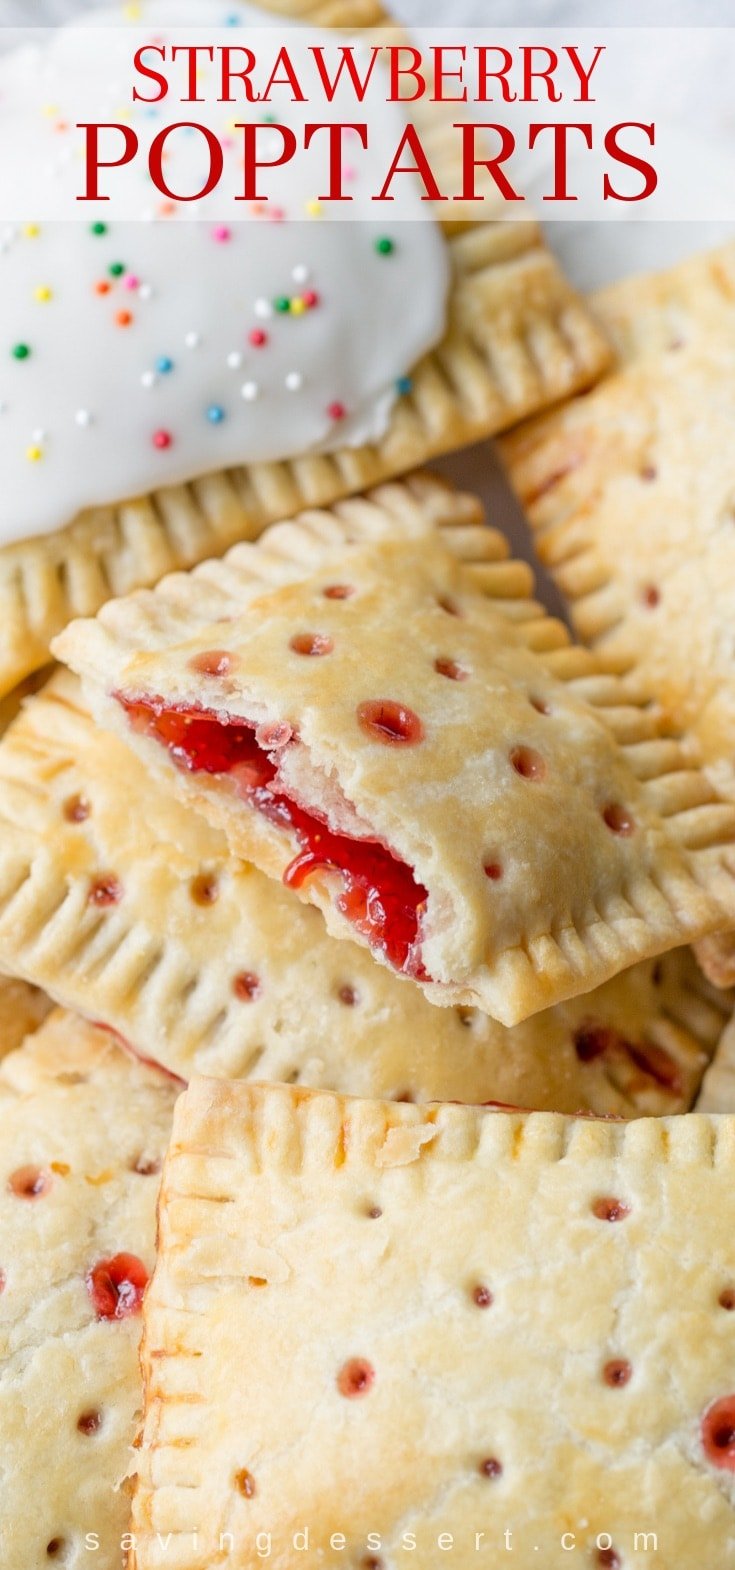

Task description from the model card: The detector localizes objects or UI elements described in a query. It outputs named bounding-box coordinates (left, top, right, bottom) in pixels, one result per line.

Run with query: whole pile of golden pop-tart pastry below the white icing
left=0, top=45, right=735, bottom=1570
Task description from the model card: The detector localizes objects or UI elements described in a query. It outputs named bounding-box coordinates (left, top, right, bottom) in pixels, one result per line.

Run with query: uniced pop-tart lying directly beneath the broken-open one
left=0, top=672, right=732, bottom=1118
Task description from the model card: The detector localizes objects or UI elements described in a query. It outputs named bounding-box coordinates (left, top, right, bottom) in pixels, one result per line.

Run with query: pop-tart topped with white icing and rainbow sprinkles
left=0, top=0, right=609, bottom=694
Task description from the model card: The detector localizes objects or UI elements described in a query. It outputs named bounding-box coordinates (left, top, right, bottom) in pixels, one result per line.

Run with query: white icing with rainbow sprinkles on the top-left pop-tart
left=0, top=0, right=448, bottom=545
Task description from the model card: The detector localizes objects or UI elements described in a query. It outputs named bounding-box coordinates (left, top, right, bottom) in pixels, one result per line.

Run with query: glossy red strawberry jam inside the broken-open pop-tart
left=115, top=692, right=427, bottom=980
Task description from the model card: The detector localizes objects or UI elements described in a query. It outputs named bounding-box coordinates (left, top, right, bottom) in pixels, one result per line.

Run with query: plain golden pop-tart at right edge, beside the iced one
left=501, top=243, right=735, bottom=799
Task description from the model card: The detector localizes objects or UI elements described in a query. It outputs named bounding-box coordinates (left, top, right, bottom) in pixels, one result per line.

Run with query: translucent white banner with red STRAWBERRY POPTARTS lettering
left=0, top=16, right=735, bottom=223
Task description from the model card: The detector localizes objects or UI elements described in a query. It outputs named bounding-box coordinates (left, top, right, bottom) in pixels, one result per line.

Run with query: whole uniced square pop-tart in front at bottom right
left=132, top=1080, right=735, bottom=1570
